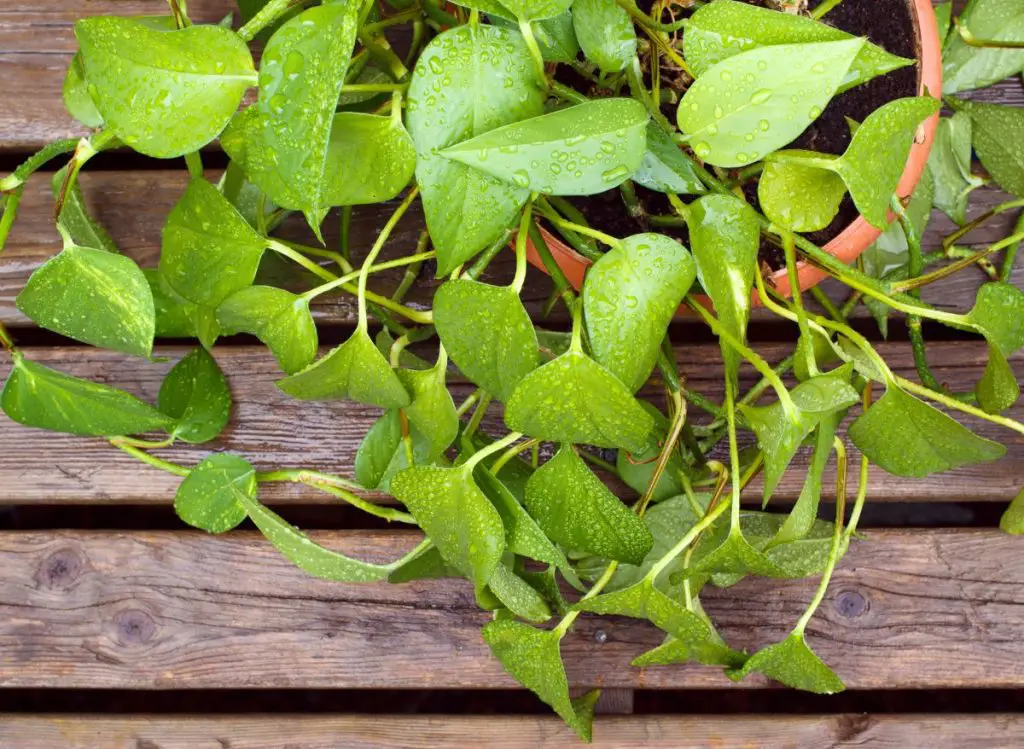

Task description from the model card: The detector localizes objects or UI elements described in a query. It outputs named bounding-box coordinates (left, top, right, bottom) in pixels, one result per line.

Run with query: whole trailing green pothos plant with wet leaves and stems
left=0, top=0, right=1024, bottom=738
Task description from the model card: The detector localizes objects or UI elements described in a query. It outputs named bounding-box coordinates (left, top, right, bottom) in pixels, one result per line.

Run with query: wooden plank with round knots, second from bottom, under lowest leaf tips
left=0, top=530, right=1024, bottom=690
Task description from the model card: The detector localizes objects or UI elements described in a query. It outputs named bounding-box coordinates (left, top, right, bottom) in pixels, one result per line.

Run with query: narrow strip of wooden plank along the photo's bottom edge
left=0, top=713, right=1024, bottom=749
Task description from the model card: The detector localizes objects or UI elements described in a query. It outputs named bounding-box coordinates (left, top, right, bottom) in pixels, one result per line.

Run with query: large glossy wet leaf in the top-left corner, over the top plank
left=75, top=15, right=255, bottom=159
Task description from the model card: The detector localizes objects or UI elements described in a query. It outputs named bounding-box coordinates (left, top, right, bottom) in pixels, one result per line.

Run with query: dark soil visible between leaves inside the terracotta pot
left=559, top=0, right=919, bottom=268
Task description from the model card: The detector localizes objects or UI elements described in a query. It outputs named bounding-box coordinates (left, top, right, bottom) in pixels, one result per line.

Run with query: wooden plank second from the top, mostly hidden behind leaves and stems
left=0, top=174, right=1024, bottom=326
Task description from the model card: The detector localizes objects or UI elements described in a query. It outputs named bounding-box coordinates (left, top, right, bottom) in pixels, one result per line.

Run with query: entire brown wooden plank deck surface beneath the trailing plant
left=0, top=0, right=1024, bottom=749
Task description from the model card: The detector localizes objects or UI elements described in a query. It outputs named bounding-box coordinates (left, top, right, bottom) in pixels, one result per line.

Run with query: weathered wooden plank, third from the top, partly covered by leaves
left=0, top=341, right=1024, bottom=504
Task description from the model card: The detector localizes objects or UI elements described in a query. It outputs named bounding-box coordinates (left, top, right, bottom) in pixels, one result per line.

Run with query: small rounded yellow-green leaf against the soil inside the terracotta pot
left=758, top=152, right=846, bottom=232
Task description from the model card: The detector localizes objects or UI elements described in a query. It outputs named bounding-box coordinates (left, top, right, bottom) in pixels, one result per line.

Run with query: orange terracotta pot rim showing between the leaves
left=527, top=0, right=942, bottom=302
